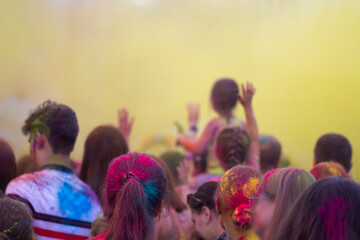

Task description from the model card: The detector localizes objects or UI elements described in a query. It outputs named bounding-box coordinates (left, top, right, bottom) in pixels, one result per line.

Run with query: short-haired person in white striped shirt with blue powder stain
left=6, top=101, right=101, bottom=240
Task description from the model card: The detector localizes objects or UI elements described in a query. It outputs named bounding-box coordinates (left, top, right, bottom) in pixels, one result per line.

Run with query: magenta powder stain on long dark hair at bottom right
left=318, top=197, right=347, bottom=240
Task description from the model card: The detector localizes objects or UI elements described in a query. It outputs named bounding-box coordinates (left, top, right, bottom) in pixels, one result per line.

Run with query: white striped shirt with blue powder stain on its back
left=5, top=164, right=102, bottom=240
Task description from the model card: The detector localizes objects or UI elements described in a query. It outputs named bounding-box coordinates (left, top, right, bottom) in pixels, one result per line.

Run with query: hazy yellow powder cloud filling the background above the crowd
left=0, top=0, right=360, bottom=181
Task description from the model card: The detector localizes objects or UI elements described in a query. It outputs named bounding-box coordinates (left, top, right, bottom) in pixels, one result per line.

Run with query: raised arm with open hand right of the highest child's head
left=238, top=82, right=260, bottom=167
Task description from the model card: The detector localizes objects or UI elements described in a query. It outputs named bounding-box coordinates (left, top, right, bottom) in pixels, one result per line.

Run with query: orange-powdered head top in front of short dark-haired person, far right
left=310, top=162, right=349, bottom=180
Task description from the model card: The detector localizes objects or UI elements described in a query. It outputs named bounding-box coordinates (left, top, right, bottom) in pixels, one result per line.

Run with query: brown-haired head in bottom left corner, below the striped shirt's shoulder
left=0, top=197, right=33, bottom=240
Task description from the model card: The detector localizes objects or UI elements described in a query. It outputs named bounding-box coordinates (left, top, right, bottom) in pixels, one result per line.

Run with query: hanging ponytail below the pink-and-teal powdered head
left=107, top=176, right=154, bottom=240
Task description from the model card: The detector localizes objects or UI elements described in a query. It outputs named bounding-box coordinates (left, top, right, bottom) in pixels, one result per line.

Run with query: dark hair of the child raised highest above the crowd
left=211, top=78, right=239, bottom=114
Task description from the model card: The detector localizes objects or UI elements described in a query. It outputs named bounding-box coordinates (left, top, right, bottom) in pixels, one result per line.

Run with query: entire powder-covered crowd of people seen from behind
left=0, top=78, right=360, bottom=240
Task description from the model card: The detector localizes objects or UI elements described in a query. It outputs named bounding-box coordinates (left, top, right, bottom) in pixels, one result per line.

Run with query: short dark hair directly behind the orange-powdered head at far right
left=314, top=133, right=352, bottom=172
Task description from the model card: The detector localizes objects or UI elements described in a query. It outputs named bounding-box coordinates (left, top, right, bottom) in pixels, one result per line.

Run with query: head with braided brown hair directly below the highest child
left=215, top=127, right=250, bottom=171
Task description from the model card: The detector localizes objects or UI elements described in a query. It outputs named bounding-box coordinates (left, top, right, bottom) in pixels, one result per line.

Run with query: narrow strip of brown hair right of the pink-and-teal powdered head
left=153, top=156, right=187, bottom=212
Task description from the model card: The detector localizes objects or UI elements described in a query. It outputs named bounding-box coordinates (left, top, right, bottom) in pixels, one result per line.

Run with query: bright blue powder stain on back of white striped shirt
left=57, top=182, right=91, bottom=219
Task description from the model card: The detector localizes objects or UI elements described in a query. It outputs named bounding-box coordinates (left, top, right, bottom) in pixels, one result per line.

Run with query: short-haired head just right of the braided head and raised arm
left=259, top=135, right=281, bottom=174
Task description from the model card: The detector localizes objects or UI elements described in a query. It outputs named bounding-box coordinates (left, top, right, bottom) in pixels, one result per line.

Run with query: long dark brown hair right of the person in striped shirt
left=79, top=126, right=129, bottom=202
